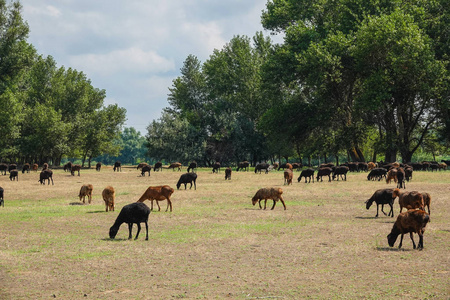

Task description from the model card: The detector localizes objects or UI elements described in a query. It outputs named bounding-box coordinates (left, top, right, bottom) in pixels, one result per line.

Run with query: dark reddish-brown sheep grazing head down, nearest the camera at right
left=387, top=209, right=430, bottom=249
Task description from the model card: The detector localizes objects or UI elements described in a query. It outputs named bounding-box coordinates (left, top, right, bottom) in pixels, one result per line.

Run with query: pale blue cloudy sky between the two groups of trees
left=20, top=0, right=282, bottom=135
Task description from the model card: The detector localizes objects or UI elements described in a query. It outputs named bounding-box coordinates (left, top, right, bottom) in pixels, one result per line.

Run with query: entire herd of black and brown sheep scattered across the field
left=0, top=160, right=450, bottom=249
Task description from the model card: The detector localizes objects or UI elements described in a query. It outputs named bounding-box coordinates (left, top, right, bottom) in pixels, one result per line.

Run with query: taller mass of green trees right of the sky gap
left=146, top=0, right=450, bottom=165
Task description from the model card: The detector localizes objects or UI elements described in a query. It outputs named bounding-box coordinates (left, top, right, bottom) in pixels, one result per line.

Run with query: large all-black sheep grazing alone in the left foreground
left=109, top=202, right=150, bottom=241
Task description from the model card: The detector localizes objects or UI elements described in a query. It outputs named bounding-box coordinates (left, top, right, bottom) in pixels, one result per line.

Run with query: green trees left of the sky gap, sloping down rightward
left=0, top=0, right=126, bottom=166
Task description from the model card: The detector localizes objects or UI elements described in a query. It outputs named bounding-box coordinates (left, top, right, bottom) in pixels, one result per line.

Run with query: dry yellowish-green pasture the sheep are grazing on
left=0, top=167, right=450, bottom=299
